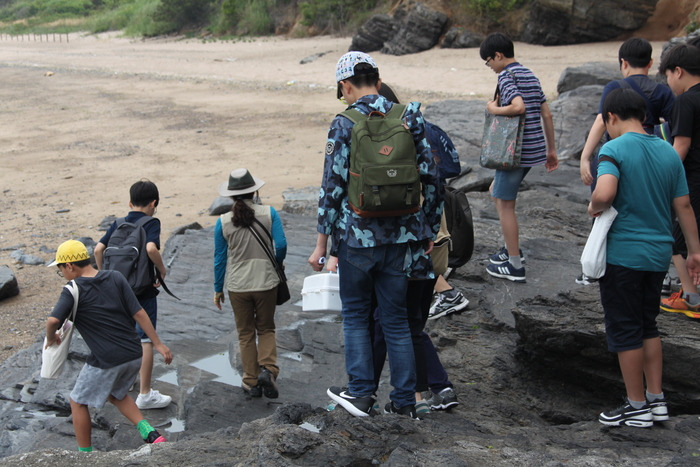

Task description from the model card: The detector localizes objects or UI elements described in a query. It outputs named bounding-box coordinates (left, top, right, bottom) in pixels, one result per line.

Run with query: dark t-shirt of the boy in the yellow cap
left=51, top=271, right=143, bottom=369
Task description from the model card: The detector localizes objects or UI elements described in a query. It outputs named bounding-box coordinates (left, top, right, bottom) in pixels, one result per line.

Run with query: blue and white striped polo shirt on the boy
left=498, top=62, right=547, bottom=167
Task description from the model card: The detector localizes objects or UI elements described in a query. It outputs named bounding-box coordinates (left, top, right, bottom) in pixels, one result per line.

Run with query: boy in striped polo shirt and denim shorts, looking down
left=479, top=32, right=559, bottom=282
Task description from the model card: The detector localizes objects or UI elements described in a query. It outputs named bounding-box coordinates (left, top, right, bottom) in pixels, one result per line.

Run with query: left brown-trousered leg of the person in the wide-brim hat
left=228, top=292, right=260, bottom=388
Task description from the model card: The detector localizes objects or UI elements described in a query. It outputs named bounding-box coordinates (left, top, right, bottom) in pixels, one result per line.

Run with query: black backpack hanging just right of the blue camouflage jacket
left=445, top=186, right=474, bottom=268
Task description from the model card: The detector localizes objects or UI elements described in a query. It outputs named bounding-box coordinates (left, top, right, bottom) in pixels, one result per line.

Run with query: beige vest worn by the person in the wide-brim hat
left=221, top=200, right=279, bottom=293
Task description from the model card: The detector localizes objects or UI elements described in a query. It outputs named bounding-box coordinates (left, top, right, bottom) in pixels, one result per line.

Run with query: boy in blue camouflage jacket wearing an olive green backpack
left=309, top=52, right=442, bottom=418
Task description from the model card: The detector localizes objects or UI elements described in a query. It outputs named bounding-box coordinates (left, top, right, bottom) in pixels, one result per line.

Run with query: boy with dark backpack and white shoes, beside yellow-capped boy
left=95, top=180, right=172, bottom=409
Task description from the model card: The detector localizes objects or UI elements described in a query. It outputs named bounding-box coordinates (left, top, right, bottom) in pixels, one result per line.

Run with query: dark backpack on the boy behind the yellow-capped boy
left=103, top=216, right=155, bottom=297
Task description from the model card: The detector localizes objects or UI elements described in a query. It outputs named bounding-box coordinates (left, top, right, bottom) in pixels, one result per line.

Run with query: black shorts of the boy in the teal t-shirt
left=599, top=263, right=666, bottom=352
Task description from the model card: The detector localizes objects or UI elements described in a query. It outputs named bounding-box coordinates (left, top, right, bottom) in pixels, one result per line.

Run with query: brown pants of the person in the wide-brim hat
left=228, top=287, right=280, bottom=387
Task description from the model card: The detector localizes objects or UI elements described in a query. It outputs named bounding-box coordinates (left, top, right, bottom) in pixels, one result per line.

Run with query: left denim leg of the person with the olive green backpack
left=338, top=242, right=378, bottom=398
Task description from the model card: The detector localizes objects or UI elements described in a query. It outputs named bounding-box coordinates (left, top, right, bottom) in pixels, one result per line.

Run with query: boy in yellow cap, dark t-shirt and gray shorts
left=46, top=240, right=173, bottom=452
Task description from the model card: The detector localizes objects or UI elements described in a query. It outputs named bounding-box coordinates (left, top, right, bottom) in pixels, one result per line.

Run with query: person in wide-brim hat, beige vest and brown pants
left=214, top=169, right=287, bottom=399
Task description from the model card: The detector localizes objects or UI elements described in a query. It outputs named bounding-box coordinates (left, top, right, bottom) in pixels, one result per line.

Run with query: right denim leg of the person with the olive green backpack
left=374, top=244, right=416, bottom=408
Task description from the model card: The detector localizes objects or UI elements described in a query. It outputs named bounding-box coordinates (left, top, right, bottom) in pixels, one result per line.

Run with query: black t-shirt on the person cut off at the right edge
left=671, top=84, right=700, bottom=179
